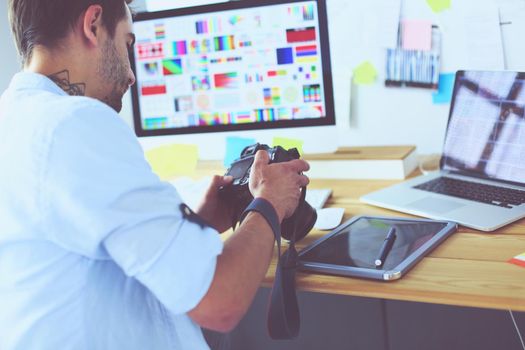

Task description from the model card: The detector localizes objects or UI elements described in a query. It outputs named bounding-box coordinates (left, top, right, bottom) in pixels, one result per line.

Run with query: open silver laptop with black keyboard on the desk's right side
left=361, top=71, right=525, bottom=231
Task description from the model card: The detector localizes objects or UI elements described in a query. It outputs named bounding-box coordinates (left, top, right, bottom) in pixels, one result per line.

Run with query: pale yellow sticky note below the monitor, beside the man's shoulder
left=146, top=144, right=199, bottom=179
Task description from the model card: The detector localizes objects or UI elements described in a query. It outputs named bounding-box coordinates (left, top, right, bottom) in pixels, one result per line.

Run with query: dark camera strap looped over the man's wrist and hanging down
left=239, top=187, right=306, bottom=339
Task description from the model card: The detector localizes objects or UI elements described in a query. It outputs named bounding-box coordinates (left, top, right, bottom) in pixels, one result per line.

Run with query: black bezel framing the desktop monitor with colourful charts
left=130, top=0, right=335, bottom=137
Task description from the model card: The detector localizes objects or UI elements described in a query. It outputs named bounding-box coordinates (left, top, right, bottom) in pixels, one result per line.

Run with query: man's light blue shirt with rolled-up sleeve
left=0, top=72, right=223, bottom=350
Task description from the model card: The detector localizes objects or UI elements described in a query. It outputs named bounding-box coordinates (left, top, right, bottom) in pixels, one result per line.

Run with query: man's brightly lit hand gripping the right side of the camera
left=250, top=151, right=310, bottom=221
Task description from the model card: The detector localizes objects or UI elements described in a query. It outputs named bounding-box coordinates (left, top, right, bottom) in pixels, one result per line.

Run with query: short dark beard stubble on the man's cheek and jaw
left=97, top=40, right=128, bottom=113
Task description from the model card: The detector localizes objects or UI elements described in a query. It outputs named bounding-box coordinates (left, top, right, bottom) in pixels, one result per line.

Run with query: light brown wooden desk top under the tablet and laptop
left=190, top=164, right=525, bottom=311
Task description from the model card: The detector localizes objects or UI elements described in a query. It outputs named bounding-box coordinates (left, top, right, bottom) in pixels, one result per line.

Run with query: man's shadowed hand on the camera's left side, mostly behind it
left=197, top=175, right=233, bottom=233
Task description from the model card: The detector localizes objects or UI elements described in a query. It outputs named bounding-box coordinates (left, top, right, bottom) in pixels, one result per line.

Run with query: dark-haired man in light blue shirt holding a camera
left=0, top=0, right=308, bottom=350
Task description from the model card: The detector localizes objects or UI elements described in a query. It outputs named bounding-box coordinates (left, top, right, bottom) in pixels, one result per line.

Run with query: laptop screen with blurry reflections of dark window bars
left=441, top=71, right=525, bottom=183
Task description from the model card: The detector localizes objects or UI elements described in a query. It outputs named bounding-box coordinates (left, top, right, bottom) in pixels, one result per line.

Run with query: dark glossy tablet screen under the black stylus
left=301, top=217, right=447, bottom=270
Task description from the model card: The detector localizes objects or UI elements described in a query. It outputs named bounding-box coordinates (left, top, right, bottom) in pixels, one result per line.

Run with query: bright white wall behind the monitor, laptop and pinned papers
left=0, top=0, right=525, bottom=153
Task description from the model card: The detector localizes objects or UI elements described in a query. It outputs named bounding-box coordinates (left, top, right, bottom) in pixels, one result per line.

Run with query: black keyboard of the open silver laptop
left=414, top=177, right=525, bottom=209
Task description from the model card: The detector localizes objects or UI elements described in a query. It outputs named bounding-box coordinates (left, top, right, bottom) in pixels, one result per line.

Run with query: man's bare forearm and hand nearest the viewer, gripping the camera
left=188, top=151, right=309, bottom=332
